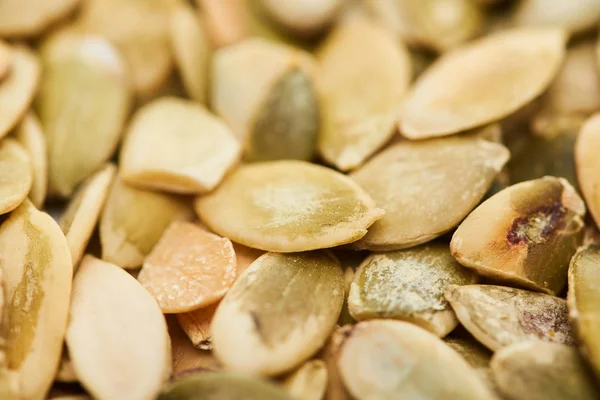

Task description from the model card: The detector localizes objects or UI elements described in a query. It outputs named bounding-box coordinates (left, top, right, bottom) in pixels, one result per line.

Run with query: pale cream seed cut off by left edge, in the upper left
left=0, top=46, right=40, bottom=138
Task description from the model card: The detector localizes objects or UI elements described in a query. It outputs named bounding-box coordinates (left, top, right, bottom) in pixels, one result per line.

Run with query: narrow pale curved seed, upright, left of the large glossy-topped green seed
left=15, top=112, right=48, bottom=209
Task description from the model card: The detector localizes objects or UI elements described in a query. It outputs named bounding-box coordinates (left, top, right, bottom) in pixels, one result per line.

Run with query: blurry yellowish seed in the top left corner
left=0, top=0, right=79, bottom=37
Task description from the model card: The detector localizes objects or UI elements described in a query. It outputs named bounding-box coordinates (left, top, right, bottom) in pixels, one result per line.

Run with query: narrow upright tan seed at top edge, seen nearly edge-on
left=169, top=3, right=210, bottom=103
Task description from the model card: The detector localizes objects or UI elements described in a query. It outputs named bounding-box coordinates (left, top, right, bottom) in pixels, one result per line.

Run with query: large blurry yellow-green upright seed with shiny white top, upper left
left=38, top=32, right=130, bottom=197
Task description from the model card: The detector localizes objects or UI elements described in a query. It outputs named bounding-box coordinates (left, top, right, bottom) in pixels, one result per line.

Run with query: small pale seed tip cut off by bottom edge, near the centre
left=282, top=360, right=327, bottom=400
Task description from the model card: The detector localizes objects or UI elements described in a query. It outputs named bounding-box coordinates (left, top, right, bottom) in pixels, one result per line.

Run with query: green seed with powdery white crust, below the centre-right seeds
left=348, top=243, right=477, bottom=337
